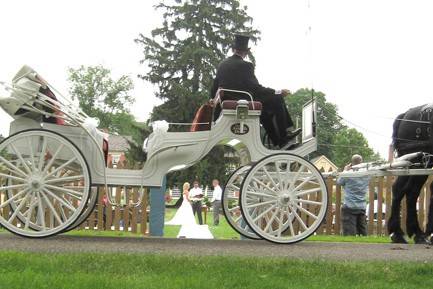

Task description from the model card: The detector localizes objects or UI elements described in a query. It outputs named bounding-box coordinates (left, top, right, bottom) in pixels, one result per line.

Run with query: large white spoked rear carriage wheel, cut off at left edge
left=0, top=129, right=91, bottom=238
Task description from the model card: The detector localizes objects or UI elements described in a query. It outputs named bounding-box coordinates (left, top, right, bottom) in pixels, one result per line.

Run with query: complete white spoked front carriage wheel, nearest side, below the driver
left=240, top=153, right=328, bottom=244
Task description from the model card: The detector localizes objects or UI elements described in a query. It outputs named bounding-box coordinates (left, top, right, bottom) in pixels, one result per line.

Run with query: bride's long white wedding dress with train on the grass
left=165, top=191, right=213, bottom=239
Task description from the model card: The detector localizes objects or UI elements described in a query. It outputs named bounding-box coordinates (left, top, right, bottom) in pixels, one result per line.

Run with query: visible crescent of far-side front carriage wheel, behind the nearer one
left=222, top=166, right=261, bottom=240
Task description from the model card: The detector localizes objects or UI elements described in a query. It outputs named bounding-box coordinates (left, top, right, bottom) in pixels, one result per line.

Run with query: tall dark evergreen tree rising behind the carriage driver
left=135, top=0, right=260, bottom=185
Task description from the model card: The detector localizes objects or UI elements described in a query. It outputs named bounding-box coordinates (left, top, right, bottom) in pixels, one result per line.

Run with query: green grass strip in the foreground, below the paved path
left=0, top=252, right=433, bottom=289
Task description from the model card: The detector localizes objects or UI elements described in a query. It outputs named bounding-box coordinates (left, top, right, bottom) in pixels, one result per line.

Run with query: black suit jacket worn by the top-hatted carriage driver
left=210, top=55, right=275, bottom=102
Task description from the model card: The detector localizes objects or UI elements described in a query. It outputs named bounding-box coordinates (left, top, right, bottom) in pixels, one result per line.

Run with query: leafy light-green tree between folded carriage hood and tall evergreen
left=68, top=66, right=134, bottom=133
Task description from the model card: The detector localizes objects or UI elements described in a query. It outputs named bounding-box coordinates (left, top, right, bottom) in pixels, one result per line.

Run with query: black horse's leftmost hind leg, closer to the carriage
left=388, top=176, right=409, bottom=243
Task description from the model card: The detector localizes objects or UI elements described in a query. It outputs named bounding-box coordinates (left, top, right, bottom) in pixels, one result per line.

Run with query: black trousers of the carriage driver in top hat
left=214, top=94, right=294, bottom=145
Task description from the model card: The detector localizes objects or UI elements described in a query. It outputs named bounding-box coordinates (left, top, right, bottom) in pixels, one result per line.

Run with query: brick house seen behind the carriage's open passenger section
left=107, top=134, right=132, bottom=169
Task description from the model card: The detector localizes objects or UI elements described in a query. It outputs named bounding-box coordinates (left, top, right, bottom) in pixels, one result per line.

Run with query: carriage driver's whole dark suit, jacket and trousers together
left=211, top=55, right=293, bottom=145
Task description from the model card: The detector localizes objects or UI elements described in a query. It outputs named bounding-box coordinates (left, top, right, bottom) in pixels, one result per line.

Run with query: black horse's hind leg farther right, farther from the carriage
left=406, top=176, right=428, bottom=244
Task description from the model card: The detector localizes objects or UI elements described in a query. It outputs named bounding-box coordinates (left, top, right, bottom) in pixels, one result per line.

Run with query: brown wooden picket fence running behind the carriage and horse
left=0, top=177, right=433, bottom=235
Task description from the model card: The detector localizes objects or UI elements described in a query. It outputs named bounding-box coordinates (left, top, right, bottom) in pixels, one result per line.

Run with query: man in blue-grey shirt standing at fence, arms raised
left=337, top=155, right=370, bottom=236
